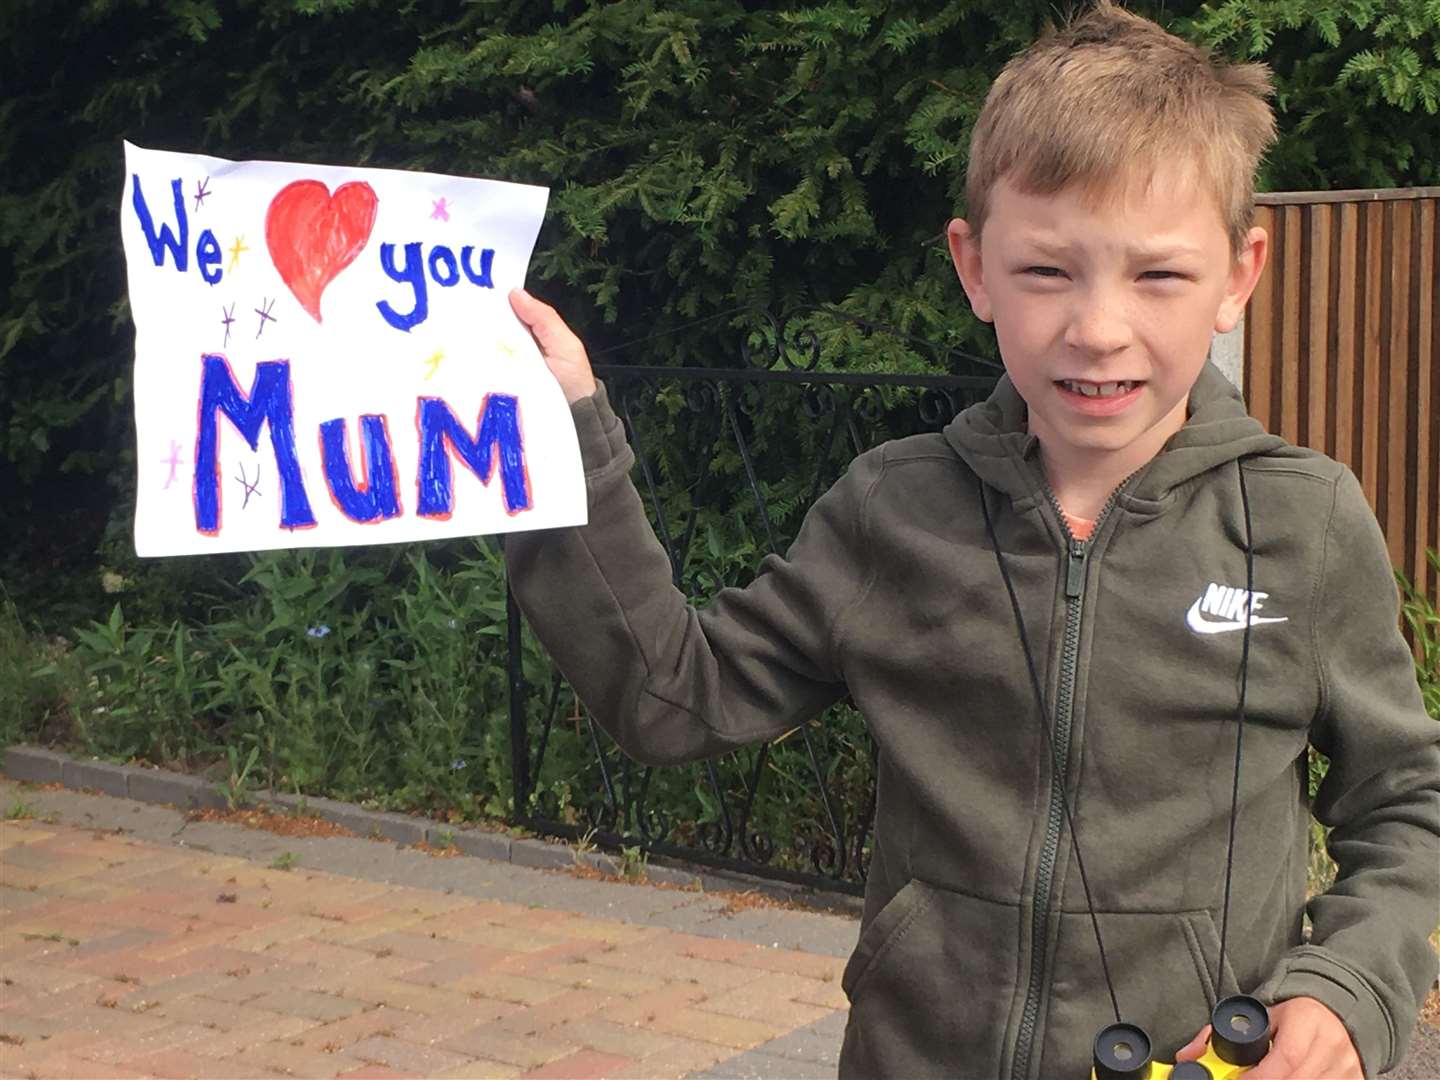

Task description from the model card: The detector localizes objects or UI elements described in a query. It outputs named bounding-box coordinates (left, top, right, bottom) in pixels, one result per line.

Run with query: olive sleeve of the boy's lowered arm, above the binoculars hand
left=1260, top=469, right=1440, bottom=1074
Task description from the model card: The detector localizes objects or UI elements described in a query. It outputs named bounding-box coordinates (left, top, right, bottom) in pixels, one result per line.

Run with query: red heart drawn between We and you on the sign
left=265, top=180, right=380, bottom=323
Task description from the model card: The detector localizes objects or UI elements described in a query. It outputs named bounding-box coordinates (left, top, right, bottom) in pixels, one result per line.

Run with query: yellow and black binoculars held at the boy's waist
left=1090, top=994, right=1270, bottom=1080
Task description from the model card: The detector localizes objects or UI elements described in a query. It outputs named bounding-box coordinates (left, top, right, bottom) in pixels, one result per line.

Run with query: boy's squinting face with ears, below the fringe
left=949, top=168, right=1266, bottom=475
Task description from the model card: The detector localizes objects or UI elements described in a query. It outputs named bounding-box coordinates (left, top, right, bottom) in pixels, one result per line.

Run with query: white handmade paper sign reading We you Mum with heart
left=121, top=143, right=585, bottom=556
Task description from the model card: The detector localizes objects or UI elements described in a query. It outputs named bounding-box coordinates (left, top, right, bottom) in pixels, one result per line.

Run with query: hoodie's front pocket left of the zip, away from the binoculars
left=840, top=881, right=1020, bottom=1077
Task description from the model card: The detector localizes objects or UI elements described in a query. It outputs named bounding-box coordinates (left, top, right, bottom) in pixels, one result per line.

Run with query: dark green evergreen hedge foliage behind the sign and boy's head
left=0, top=0, right=1440, bottom=626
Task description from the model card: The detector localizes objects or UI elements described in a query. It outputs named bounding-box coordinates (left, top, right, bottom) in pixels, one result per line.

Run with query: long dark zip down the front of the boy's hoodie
left=1011, top=477, right=1130, bottom=1080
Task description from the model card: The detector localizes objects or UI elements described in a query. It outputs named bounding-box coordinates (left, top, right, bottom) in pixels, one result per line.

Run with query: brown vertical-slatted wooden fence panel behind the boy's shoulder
left=1244, top=187, right=1440, bottom=598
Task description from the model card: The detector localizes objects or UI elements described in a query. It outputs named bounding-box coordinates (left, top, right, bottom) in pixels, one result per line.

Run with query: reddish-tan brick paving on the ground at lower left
left=0, top=821, right=845, bottom=1077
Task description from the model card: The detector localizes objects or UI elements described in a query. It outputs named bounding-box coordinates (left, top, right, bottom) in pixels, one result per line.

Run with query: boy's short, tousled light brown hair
left=965, top=0, right=1274, bottom=252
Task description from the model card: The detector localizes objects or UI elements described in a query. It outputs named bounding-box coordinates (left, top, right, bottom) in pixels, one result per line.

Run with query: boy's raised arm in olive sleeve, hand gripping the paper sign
left=505, top=291, right=878, bottom=765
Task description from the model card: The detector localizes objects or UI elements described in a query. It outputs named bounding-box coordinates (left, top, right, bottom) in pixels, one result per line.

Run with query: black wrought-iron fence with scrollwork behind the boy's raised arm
left=508, top=308, right=999, bottom=893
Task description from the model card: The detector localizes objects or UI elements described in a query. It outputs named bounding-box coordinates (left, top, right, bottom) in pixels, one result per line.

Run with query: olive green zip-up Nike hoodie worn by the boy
left=507, top=367, right=1440, bottom=1080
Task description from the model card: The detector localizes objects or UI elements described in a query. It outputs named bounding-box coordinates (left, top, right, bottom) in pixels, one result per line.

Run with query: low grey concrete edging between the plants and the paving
left=0, top=744, right=860, bottom=913
